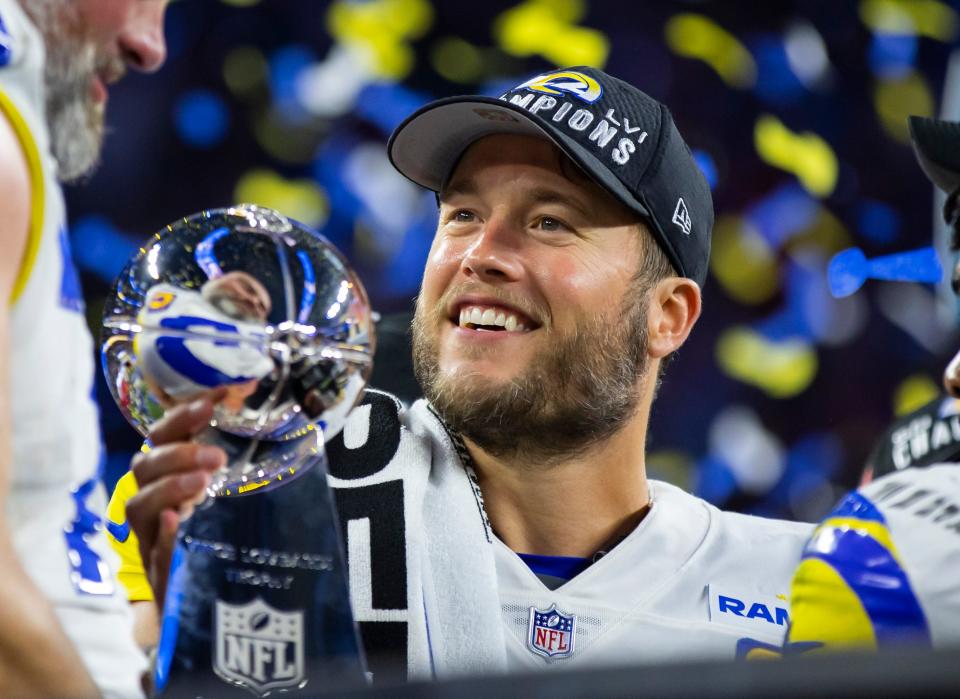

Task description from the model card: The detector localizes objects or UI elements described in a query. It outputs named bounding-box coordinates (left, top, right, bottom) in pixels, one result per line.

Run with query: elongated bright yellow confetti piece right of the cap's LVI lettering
left=753, top=114, right=839, bottom=197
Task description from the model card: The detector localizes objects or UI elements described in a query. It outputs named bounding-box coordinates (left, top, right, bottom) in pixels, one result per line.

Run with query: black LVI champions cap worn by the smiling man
left=387, top=66, right=713, bottom=286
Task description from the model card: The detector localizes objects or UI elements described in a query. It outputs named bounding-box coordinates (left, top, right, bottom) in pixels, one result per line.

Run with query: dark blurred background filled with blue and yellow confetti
left=67, top=0, right=960, bottom=519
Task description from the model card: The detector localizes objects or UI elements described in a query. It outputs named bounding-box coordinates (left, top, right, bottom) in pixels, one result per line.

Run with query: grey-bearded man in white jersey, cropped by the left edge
left=0, top=0, right=166, bottom=697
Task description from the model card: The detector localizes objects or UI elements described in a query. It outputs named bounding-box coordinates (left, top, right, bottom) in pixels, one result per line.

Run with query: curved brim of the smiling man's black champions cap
left=387, top=96, right=650, bottom=218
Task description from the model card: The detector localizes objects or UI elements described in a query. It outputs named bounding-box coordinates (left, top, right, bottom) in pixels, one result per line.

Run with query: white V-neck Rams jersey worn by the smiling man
left=495, top=481, right=811, bottom=670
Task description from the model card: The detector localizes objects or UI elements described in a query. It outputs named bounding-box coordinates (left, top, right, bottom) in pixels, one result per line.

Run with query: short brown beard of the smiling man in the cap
left=413, top=282, right=649, bottom=467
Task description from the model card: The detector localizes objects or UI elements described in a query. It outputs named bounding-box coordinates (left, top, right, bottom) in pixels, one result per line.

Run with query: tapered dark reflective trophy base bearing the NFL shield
left=155, top=452, right=366, bottom=699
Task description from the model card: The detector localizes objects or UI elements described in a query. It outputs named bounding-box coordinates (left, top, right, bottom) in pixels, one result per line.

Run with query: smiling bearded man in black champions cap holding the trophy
left=127, top=68, right=810, bottom=678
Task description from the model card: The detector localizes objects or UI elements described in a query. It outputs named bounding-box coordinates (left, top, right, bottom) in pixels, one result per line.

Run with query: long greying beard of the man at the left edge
left=21, top=0, right=115, bottom=182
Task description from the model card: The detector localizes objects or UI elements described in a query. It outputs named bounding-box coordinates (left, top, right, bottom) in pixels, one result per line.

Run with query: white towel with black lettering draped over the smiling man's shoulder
left=327, top=390, right=506, bottom=681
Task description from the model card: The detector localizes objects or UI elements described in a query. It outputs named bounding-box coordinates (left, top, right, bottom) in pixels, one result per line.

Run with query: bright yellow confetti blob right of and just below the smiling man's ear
left=716, top=327, right=819, bottom=398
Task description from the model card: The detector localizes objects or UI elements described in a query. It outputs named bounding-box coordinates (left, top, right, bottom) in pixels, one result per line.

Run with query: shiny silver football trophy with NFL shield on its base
left=102, top=205, right=374, bottom=697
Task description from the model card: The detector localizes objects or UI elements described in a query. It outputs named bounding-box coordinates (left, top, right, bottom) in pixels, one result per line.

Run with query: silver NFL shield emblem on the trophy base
left=213, top=598, right=304, bottom=697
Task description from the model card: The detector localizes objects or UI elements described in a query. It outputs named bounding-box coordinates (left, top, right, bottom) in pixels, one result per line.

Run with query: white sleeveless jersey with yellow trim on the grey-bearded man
left=0, top=0, right=145, bottom=697
